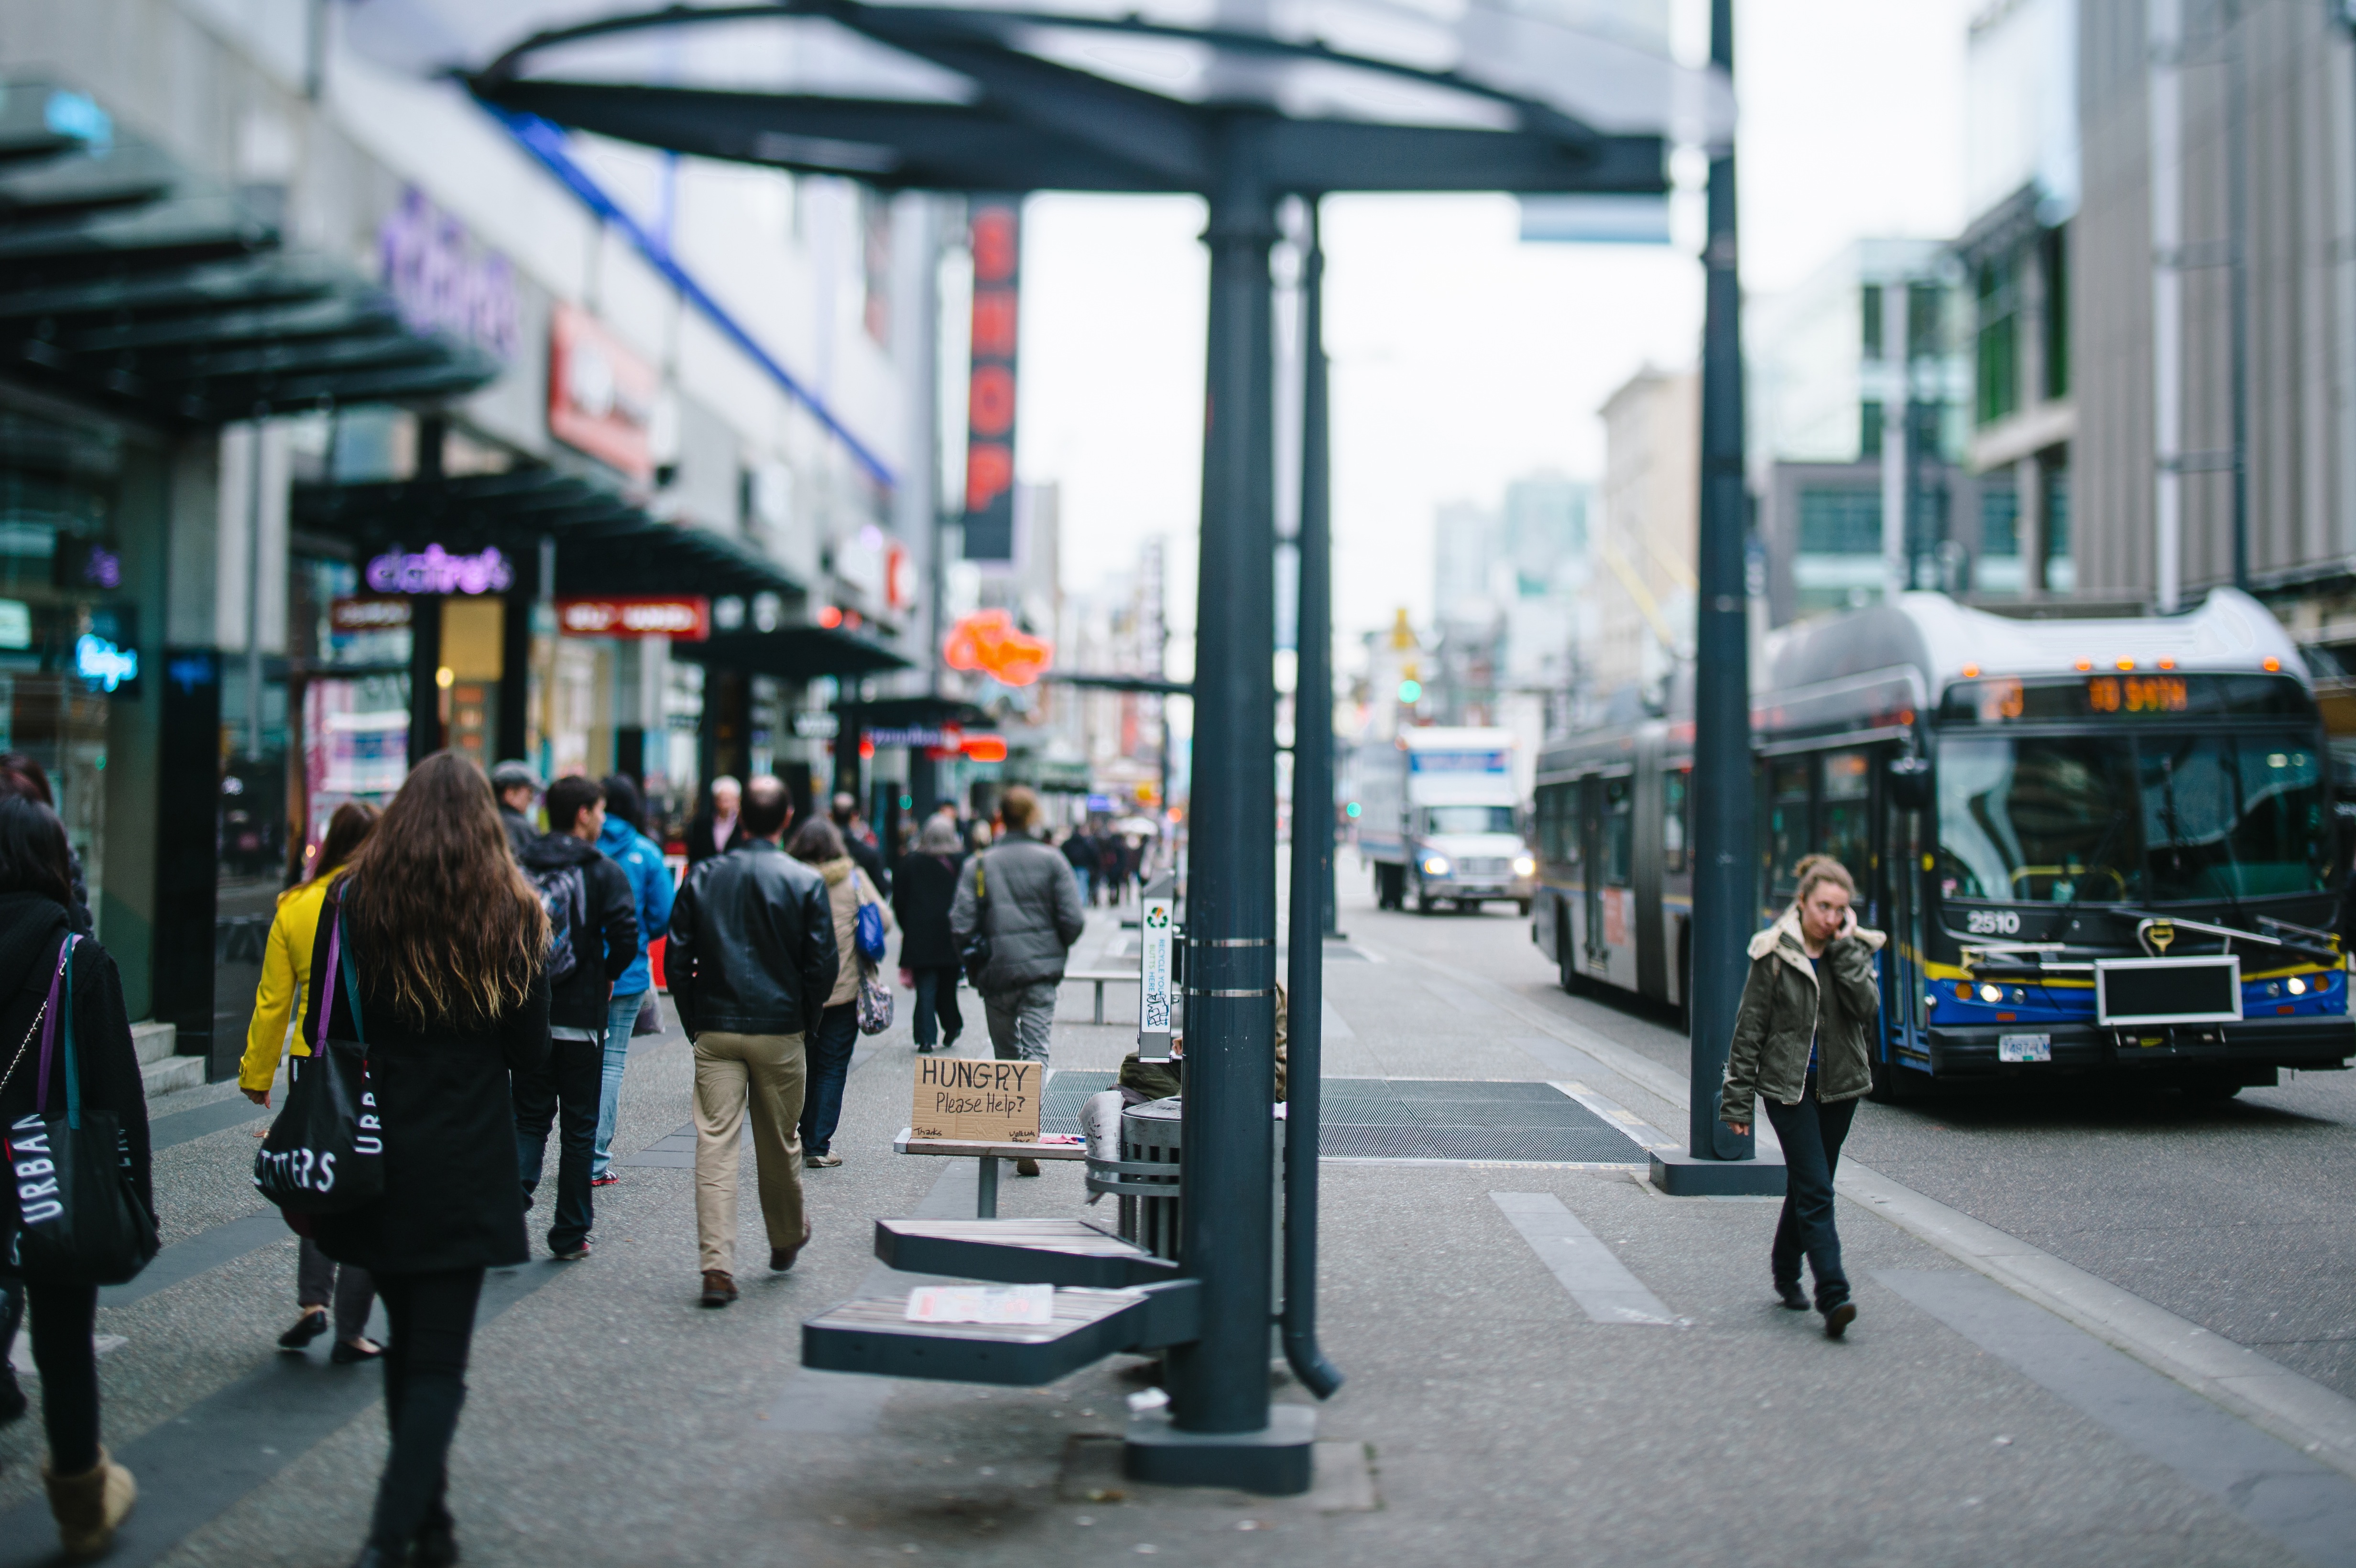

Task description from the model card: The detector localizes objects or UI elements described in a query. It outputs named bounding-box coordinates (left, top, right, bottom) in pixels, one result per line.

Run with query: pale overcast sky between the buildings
left=1018, top=0, right=1977, bottom=666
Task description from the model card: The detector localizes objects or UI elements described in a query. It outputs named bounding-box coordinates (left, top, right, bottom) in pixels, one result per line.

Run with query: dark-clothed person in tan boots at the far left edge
left=0, top=796, right=155, bottom=1558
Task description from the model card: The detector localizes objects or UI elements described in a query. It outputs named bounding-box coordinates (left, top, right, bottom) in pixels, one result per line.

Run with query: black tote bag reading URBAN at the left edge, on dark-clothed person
left=7, top=937, right=160, bottom=1285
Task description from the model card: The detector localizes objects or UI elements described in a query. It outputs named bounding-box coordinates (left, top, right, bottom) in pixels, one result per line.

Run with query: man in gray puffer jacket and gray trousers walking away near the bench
left=949, top=784, right=1086, bottom=1062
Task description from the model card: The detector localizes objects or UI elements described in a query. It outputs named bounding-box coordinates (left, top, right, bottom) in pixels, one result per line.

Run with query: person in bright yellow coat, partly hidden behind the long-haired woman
left=238, top=800, right=384, bottom=1363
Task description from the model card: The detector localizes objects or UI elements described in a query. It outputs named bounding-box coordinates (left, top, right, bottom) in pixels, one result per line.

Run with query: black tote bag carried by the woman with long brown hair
left=254, top=902, right=384, bottom=1231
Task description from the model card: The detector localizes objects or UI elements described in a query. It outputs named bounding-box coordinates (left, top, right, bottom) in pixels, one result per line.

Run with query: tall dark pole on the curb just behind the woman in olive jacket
left=1652, top=0, right=1783, bottom=1196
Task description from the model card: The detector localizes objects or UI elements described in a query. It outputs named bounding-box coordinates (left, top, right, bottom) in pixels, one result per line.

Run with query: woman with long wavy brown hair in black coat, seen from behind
left=304, top=751, right=549, bottom=1568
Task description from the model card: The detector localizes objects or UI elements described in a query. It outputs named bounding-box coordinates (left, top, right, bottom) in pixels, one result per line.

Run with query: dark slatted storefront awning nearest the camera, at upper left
left=0, top=80, right=500, bottom=426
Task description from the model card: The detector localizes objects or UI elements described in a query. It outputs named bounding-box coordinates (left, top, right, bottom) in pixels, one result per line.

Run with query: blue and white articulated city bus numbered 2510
left=1531, top=588, right=2356, bottom=1100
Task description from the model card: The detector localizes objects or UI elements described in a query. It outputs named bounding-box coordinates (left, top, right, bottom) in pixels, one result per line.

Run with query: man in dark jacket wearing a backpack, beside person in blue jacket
left=516, top=774, right=638, bottom=1262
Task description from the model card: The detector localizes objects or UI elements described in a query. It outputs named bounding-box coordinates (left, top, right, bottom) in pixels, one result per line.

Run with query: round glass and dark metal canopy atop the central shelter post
left=353, top=0, right=1727, bottom=196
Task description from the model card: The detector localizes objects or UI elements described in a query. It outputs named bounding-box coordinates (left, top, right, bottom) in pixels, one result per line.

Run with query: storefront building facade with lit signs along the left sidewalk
left=0, top=0, right=957, bottom=1076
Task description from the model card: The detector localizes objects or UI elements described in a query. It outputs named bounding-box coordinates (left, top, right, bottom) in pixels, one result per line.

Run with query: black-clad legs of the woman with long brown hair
left=368, top=1269, right=483, bottom=1561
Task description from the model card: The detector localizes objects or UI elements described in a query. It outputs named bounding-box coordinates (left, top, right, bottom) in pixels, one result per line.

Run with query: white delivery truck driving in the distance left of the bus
left=1353, top=725, right=1538, bottom=914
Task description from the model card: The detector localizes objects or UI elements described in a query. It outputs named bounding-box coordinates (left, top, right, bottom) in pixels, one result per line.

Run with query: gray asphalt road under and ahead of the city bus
left=1329, top=852, right=2356, bottom=1396
